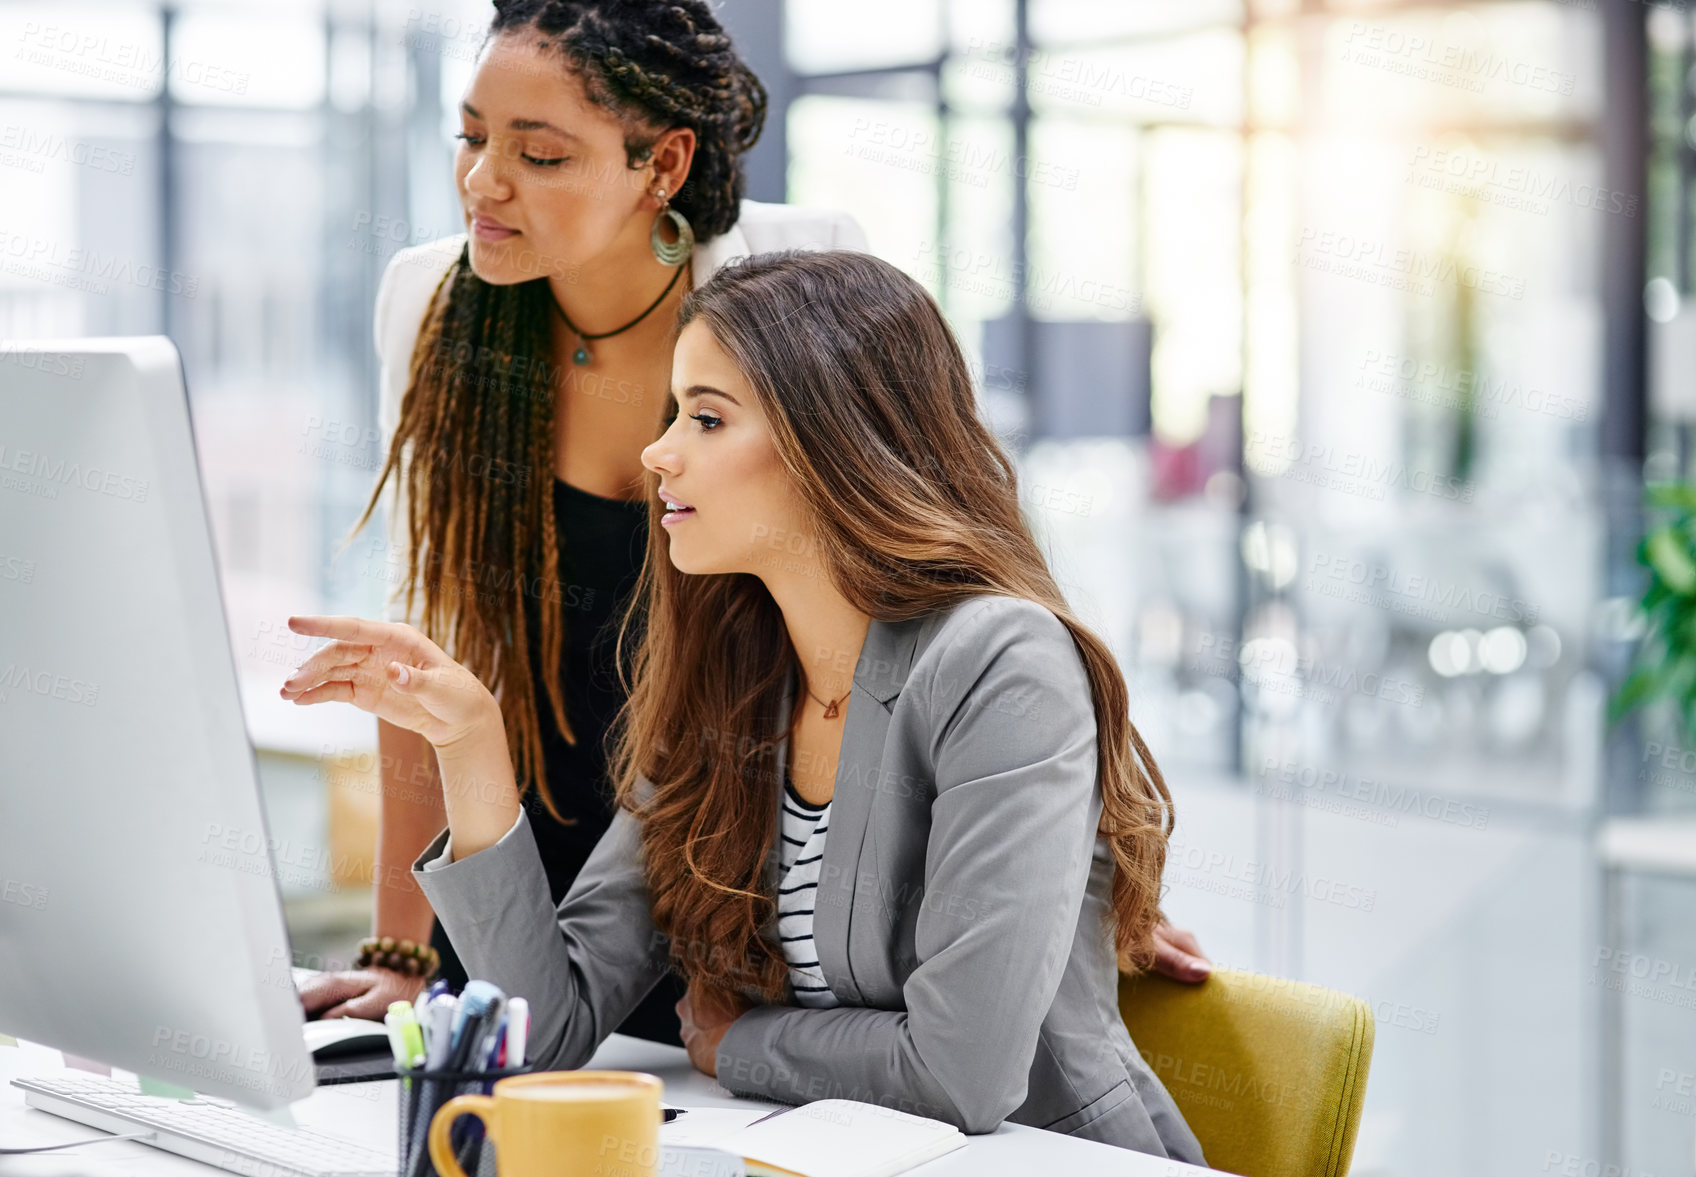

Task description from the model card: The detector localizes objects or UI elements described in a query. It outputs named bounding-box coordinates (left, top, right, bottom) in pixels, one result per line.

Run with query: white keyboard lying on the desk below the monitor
left=12, top=1075, right=397, bottom=1177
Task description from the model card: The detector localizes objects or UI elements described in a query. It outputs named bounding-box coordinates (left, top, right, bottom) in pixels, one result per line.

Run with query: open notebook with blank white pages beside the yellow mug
left=660, top=1099, right=965, bottom=1177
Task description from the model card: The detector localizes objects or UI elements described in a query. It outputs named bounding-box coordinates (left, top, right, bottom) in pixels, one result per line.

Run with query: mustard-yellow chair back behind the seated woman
left=1119, top=968, right=1374, bottom=1177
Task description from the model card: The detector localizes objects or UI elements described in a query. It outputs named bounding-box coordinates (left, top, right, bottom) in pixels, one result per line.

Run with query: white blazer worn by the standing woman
left=368, top=200, right=867, bottom=637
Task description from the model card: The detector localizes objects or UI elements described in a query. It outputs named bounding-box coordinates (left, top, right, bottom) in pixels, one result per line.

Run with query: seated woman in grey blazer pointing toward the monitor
left=290, top=251, right=1202, bottom=1163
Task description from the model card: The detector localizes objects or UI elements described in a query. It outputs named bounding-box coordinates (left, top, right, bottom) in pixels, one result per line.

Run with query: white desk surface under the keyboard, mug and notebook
left=0, top=1035, right=1218, bottom=1177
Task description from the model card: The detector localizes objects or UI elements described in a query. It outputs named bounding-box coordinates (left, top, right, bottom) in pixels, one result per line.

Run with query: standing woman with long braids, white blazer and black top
left=283, top=0, right=865, bottom=1043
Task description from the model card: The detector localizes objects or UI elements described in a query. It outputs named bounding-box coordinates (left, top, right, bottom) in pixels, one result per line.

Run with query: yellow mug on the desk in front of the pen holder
left=429, top=1070, right=665, bottom=1177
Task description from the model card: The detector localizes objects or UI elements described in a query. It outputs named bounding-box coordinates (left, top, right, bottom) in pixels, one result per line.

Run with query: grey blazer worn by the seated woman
left=414, top=595, right=1202, bottom=1165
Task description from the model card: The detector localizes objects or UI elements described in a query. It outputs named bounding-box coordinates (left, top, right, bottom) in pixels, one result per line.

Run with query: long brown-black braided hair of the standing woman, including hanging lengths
left=353, top=0, right=767, bottom=821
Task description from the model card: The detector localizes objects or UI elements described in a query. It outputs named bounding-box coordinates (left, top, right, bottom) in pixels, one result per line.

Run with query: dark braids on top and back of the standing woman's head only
left=488, top=0, right=767, bottom=241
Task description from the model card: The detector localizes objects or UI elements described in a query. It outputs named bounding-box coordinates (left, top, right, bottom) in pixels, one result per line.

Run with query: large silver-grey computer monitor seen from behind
left=0, top=336, right=314, bottom=1107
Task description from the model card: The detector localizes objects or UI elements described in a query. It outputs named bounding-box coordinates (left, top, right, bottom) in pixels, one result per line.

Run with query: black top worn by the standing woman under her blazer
left=431, top=478, right=683, bottom=1045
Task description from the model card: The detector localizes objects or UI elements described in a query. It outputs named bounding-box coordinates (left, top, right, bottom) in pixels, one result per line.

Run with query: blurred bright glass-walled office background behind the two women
left=0, top=0, right=1696, bottom=1177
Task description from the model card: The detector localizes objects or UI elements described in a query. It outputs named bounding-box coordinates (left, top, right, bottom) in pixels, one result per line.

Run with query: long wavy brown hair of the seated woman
left=611, top=251, right=1172, bottom=999
